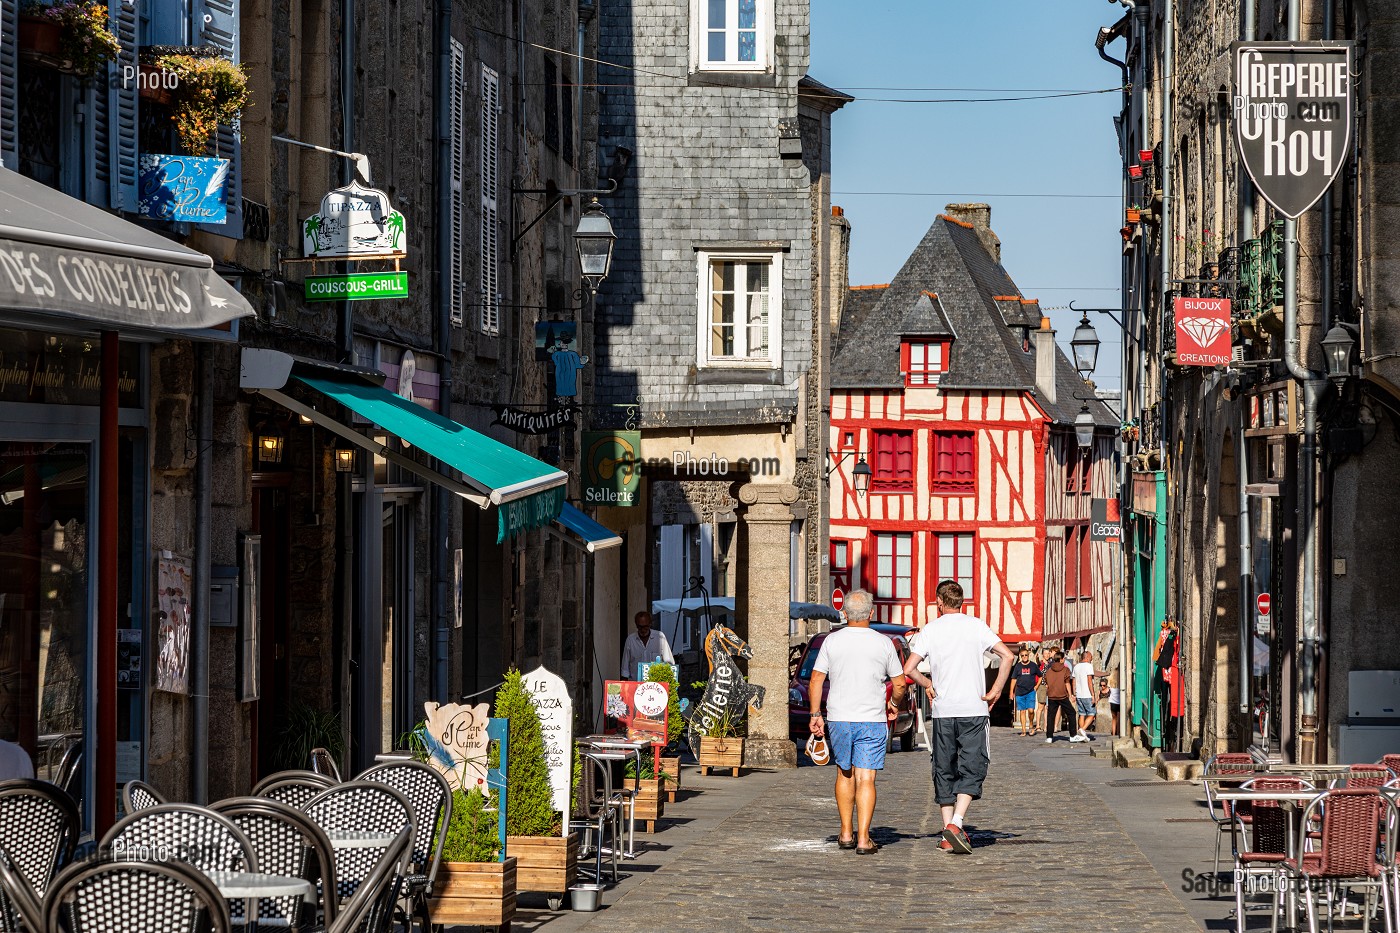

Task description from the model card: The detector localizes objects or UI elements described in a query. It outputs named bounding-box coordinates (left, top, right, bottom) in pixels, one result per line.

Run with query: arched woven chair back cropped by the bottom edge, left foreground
left=39, top=860, right=232, bottom=933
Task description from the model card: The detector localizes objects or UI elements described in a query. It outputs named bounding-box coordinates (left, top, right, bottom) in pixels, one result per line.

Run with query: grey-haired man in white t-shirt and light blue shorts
left=808, top=590, right=907, bottom=855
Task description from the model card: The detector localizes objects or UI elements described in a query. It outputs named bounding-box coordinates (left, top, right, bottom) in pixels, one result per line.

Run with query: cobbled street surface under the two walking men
left=517, top=728, right=1220, bottom=933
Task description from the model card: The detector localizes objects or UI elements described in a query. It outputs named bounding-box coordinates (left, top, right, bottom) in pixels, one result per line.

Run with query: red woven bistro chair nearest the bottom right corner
left=1280, top=787, right=1396, bottom=933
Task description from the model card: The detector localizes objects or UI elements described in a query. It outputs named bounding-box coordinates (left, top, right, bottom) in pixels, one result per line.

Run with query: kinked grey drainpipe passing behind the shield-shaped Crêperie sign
left=1284, top=1, right=1327, bottom=765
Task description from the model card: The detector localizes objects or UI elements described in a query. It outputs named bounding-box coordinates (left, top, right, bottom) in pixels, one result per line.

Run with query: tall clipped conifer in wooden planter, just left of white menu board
left=496, top=668, right=578, bottom=909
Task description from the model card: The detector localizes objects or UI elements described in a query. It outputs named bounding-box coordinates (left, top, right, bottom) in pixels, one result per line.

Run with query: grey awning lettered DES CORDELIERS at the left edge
left=0, top=168, right=253, bottom=331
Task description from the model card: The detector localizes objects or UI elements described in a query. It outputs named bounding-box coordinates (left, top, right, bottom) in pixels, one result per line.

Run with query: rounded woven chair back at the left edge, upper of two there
left=0, top=779, right=80, bottom=933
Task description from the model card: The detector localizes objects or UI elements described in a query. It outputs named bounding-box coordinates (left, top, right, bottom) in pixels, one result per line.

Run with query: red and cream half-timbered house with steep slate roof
left=829, top=205, right=1116, bottom=642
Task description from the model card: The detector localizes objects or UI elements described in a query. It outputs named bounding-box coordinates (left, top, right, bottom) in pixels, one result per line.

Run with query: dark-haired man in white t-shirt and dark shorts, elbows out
left=904, top=580, right=1015, bottom=855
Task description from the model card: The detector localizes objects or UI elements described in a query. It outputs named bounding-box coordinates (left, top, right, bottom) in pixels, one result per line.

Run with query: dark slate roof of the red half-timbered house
left=832, top=214, right=1117, bottom=426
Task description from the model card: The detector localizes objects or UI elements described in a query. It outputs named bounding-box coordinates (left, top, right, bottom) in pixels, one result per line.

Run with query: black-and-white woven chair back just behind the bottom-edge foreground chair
left=98, top=804, right=259, bottom=871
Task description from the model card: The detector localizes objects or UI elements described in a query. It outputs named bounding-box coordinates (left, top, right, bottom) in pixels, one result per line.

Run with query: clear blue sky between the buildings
left=809, top=0, right=1123, bottom=388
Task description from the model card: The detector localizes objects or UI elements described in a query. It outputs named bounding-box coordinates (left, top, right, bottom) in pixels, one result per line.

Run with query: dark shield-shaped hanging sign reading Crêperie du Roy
left=1232, top=42, right=1355, bottom=217
